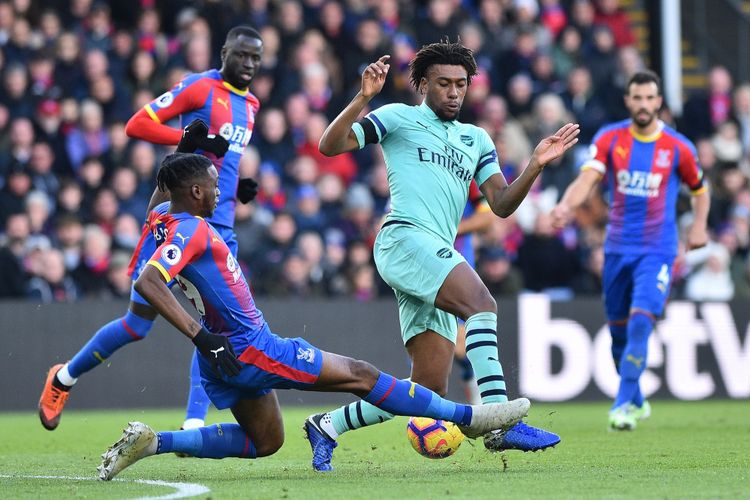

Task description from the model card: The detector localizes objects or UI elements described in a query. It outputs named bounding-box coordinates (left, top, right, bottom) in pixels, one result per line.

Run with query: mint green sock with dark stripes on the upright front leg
left=466, top=312, right=508, bottom=403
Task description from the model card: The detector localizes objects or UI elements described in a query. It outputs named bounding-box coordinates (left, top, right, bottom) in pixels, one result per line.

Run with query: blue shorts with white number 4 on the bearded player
left=602, top=253, right=675, bottom=321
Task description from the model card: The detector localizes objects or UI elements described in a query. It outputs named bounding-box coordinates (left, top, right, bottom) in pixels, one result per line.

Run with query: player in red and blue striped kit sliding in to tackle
left=98, top=154, right=530, bottom=480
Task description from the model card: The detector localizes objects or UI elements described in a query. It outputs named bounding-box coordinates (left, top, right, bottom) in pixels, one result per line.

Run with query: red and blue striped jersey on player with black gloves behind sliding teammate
left=144, top=69, right=260, bottom=227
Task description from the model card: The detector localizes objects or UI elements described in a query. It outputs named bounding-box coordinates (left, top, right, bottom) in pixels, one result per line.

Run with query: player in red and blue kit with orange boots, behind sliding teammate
left=39, top=26, right=263, bottom=430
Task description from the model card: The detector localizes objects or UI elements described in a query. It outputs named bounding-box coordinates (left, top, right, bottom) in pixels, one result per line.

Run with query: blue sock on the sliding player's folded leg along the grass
left=156, top=424, right=255, bottom=458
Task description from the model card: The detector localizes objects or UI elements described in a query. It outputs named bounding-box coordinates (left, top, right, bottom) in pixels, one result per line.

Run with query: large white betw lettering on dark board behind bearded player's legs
left=516, top=295, right=750, bottom=401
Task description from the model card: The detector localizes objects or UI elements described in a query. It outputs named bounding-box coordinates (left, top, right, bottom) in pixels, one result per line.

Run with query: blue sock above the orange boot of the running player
left=68, top=311, right=154, bottom=378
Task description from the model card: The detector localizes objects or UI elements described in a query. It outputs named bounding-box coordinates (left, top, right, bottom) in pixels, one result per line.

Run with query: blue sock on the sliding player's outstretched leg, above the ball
left=362, top=372, right=472, bottom=425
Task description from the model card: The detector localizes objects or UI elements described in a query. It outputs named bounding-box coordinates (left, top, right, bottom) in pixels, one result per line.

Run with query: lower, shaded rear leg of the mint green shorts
left=395, top=290, right=458, bottom=345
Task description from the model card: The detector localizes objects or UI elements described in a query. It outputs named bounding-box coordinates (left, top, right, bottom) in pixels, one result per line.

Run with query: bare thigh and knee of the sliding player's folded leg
left=232, top=391, right=284, bottom=457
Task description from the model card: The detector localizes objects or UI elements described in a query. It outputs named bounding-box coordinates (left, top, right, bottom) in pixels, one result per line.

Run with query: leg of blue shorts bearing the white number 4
left=631, top=254, right=674, bottom=316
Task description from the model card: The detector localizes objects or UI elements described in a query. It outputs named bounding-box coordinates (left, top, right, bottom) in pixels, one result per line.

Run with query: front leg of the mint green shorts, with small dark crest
left=373, top=225, right=466, bottom=304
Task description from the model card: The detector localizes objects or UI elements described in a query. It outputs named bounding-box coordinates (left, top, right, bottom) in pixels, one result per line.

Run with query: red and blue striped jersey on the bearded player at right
left=581, top=120, right=705, bottom=255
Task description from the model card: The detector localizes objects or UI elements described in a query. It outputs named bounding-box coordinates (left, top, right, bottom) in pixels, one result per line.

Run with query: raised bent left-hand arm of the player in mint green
left=318, top=55, right=391, bottom=156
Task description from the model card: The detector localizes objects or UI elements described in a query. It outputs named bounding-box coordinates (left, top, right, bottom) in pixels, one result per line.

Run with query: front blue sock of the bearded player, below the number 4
left=613, top=312, right=654, bottom=408
